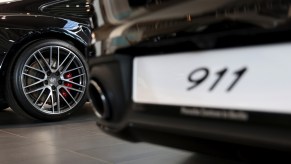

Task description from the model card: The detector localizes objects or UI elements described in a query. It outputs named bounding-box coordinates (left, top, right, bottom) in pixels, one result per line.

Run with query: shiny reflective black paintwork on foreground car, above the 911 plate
left=95, top=0, right=291, bottom=54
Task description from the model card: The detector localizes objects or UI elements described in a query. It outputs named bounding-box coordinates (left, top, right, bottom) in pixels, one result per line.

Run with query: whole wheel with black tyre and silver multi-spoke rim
left=6, top=39, right=88, bottom=121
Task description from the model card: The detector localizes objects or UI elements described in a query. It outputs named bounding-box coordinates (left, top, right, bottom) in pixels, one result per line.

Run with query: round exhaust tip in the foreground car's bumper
left=89, top=80, right=110, bottom=119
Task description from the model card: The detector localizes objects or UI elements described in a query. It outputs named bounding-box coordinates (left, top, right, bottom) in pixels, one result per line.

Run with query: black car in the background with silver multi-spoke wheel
left=0, top=0, right=92, bottom=121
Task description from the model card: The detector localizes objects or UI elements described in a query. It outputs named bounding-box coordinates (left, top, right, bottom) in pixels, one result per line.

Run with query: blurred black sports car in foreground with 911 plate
left=89, top=0, right=291, bottom=155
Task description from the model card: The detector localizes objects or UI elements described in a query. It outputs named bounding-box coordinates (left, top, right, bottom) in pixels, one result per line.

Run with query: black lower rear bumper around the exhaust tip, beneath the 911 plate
left=90, top=55, right=291, bottom=153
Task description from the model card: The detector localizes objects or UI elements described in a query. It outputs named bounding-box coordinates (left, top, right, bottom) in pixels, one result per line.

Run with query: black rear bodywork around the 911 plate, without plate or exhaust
left=90, top=0, right=291, bottom=155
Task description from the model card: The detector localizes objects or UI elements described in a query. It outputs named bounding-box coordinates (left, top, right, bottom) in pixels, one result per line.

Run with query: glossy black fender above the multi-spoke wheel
left=0, top=0, right=91, bottom=101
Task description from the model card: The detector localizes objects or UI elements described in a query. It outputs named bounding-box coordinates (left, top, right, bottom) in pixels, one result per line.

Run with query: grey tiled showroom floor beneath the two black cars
left=0, top=104, right=242, bottom=164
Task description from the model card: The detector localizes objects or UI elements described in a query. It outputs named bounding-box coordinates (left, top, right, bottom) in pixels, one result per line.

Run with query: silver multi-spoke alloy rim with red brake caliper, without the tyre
left=21, top=46, right=87, bottom=114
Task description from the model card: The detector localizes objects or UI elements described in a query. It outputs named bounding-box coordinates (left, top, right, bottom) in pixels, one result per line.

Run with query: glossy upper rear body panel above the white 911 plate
left=94, top=0, right=291, bottom=56
